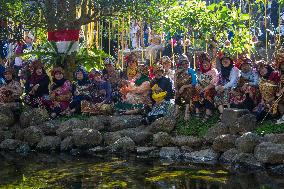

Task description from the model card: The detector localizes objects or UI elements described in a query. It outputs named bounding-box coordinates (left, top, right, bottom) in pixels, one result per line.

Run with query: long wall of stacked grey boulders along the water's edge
left=0, top=105, right=284, bottom=174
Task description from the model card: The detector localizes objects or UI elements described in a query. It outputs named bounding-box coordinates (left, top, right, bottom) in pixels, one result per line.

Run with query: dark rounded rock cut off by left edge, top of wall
left=0, top=106, right=15, bottom=130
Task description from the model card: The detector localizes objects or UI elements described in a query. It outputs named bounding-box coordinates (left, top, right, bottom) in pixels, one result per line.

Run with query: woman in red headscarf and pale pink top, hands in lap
left=193, top=52, right=218, bottom=121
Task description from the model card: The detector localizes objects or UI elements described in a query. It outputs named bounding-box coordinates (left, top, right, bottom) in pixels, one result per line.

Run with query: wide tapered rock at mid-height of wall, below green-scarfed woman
left=119, top=127, right=153, bottom=145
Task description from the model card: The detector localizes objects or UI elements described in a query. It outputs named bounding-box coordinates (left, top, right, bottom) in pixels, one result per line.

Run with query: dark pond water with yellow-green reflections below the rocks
left=0, top=153, right=284, bottom=189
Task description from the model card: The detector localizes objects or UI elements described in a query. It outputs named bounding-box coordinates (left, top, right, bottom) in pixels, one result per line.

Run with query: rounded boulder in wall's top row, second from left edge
left=20, top=108, right=49, bottom=128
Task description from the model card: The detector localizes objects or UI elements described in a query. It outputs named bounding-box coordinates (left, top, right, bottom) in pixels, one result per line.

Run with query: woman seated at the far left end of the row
left=0, top=68, right=23, bottom=103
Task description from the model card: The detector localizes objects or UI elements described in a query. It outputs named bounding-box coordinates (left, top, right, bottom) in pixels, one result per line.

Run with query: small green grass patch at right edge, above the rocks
left=256, top=121, right=284, bottom=135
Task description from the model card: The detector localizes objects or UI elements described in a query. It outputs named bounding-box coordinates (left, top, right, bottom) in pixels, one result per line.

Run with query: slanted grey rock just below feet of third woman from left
left=56, top=118, right=86, bottom=138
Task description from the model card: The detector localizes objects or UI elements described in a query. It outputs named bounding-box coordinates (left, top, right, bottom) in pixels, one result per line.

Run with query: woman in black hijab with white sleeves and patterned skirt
left=214, top=56, right=240, bottom=118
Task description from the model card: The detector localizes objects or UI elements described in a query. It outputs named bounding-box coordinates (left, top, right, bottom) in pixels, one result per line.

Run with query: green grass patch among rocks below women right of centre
left=177, top=114, right=219, bottom=137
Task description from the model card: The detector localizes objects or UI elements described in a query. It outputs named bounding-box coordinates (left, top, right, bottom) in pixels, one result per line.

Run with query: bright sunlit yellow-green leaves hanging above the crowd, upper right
left=163, top=0, right=253, bottom=54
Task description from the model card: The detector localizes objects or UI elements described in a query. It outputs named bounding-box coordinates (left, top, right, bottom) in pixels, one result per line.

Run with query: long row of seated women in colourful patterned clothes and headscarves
left=0, top=47, right=284, bottom=124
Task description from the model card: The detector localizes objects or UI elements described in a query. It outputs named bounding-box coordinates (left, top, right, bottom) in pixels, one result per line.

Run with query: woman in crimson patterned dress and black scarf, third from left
left=45, top=67, right=72, bottom=118
